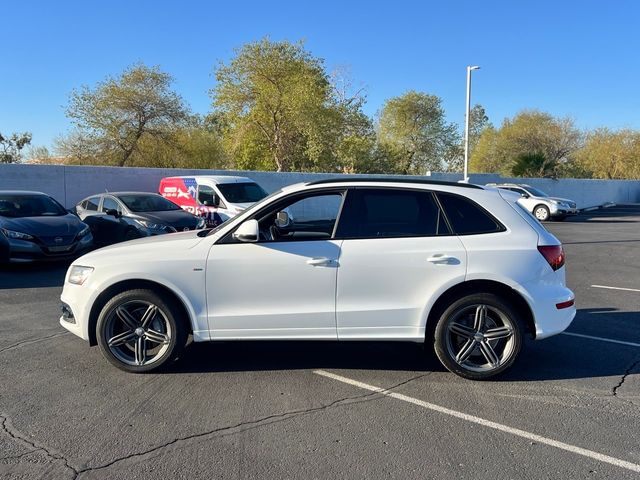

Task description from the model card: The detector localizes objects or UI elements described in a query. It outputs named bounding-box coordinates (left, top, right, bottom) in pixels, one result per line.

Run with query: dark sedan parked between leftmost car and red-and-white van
left=75, top=192, right=205, bottom=246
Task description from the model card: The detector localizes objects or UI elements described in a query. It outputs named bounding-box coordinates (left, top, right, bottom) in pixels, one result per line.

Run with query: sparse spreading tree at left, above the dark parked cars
left=58, top=64, right=189, bottom=166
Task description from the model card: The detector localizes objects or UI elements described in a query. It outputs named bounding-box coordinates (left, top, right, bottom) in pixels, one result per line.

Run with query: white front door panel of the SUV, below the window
left=207, top=240, right=342, bottom=340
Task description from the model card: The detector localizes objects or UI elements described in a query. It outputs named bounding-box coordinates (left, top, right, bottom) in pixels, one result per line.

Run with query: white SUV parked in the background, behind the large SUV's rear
left=487, top=183, right=578, bottom=222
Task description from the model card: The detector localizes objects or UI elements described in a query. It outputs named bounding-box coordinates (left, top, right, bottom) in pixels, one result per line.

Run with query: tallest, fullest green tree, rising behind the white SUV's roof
left=210, top=39, right=343, bottom=172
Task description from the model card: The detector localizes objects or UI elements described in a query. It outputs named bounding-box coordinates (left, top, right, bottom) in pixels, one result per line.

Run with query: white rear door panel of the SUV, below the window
left=337, top=235, right=467, bottom=341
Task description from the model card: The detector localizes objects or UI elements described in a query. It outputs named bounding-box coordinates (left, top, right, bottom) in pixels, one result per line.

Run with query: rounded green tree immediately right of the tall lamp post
left=471, top=110, right=582, bottom=177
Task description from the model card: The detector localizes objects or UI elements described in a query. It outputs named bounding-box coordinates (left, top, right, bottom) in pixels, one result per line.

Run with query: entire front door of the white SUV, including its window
left=206, top=191, right=343, bottom=339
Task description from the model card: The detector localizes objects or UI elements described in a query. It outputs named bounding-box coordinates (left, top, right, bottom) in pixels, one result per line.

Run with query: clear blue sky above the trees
left=0, top=0, right=640, bottom=147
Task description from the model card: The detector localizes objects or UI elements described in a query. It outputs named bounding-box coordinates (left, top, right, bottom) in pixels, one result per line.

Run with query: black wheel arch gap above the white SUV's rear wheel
left=425, top=280, right=536, bottom=342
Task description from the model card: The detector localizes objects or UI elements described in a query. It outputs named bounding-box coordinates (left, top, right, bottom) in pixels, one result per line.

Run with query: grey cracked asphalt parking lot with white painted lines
left=0, top=206, right=640, bottom=479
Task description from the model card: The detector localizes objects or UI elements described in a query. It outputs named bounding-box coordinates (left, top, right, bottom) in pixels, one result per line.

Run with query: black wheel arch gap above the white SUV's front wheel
left=87, top=279, right=194, bottom=346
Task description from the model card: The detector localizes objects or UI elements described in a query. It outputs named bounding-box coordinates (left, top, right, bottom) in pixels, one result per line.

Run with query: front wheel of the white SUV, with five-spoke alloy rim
left=96, top=289, right=187, bottom=373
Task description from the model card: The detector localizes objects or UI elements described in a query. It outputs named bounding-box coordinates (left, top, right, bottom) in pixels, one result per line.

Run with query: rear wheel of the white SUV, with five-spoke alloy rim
left=434, top=293, right=523, bottom=380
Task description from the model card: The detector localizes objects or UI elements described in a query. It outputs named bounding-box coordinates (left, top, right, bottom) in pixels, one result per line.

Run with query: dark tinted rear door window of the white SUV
left=337, top=189, right=450, bottom=238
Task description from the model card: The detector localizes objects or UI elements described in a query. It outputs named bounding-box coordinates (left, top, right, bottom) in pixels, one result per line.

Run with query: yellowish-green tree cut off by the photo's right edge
left=576, top=128, right=640, bottom=179
